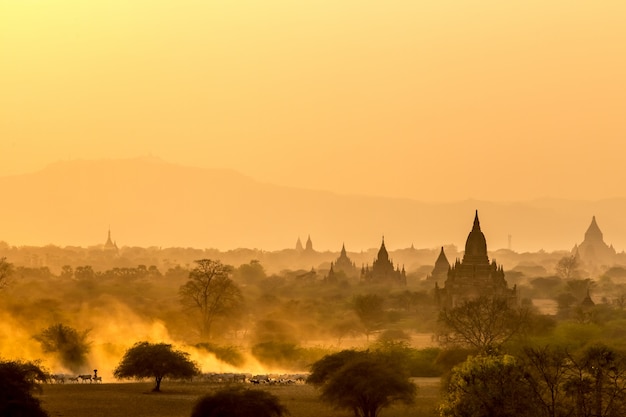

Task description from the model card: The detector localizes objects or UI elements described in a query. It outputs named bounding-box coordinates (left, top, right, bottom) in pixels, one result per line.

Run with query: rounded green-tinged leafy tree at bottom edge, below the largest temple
left=439, top=355, right=539, bottom=417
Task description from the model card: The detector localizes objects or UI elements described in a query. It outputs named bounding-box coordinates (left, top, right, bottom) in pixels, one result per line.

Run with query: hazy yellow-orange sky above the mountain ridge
left=0, top=0, right=626, bottom=201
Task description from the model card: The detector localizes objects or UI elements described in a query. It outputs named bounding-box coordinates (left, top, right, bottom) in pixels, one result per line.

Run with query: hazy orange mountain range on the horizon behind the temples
left=0, top=158, right=626, bottom=252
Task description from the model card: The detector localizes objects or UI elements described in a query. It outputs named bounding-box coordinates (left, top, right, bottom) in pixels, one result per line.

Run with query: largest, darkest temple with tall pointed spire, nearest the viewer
left=435, top=210, right=517, bottom=308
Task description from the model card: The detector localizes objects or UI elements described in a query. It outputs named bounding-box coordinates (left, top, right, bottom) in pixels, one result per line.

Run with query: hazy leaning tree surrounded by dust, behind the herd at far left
left=34, top=323, right=90, bottom=372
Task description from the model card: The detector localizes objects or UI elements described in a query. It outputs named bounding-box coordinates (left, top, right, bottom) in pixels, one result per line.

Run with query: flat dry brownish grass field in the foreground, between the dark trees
left=39, top=378, right=439, bottom=417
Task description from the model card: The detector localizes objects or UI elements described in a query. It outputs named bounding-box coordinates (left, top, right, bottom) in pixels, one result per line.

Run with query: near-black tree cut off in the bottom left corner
left=0, top=361, right=48, bottom=417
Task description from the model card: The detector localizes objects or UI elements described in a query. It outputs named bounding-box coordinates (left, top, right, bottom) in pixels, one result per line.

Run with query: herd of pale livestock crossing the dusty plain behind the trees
left=40, top=372, right=307, bottom=385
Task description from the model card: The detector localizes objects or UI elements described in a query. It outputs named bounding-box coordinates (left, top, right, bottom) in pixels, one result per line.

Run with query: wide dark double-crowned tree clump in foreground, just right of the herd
left=307, top=350, right=417, bottom=417
